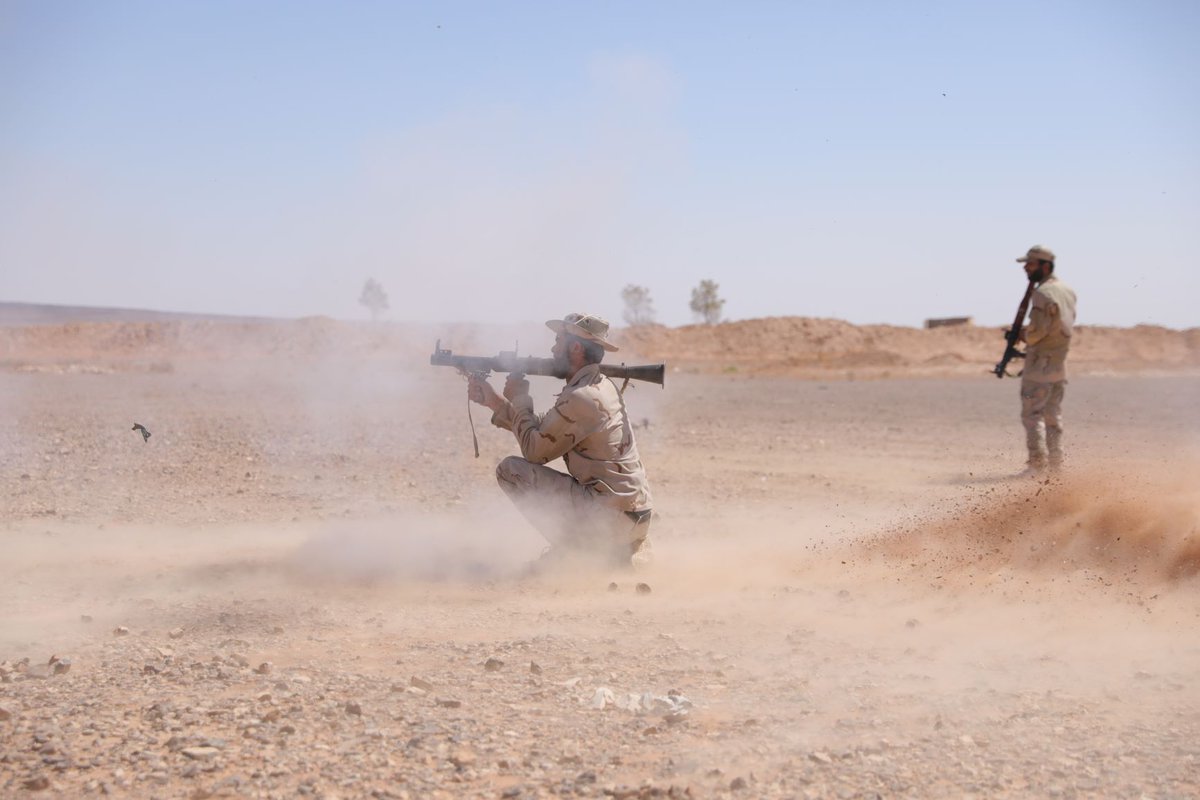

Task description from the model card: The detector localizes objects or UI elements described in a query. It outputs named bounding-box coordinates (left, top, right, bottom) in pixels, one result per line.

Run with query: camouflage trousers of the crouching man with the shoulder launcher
left=496, top=456, right=650, bottom=566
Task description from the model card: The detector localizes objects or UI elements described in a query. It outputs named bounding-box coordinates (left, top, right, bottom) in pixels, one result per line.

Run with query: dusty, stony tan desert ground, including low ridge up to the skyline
left=0, top=318, right=1200, bottom=800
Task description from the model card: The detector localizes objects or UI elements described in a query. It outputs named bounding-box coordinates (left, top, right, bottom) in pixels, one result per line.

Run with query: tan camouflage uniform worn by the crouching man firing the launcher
left=492, top=363, right=650, bottom=564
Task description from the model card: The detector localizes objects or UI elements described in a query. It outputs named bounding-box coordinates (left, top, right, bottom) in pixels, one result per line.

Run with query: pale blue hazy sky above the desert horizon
left=0, top=0, right=1200, bottom=327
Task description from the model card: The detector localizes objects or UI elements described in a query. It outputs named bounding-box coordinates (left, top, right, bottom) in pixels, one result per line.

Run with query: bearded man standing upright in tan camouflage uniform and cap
left=1016, top=245, right=1075, bottom=473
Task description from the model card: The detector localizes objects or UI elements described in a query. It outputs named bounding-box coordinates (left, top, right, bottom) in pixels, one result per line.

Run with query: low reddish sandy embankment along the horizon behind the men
left=0, top=303, right=1200, bottom=379
